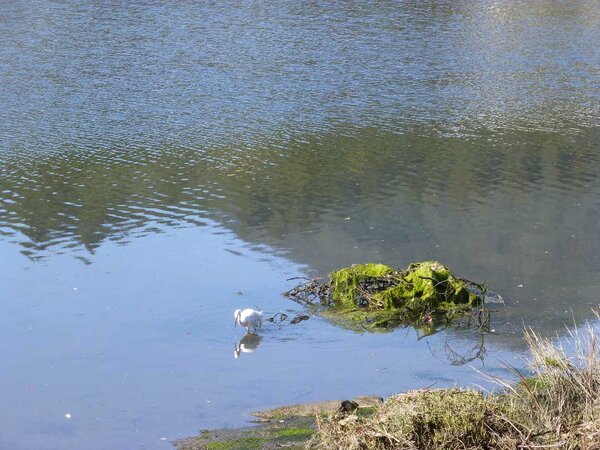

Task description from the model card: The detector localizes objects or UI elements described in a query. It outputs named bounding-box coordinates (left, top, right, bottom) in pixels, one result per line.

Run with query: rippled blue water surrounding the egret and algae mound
left=0, top=1, right=600, bottom=450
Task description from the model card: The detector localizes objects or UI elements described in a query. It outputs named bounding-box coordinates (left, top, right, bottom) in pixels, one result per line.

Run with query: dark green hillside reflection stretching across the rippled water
left=0, top=128, right=600, bottom=329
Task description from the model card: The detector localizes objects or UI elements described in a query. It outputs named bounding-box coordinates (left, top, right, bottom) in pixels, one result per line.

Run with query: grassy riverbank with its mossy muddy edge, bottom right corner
left=174, top=327, right=600, bottom=450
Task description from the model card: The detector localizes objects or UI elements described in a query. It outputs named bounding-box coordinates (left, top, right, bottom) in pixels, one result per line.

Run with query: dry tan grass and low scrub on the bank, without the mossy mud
left=310, top=314, right=600, bottom=450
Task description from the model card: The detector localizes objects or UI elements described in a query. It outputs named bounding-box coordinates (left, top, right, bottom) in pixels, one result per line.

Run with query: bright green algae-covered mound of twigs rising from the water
left=285, top=261, right=485, bottom=333
